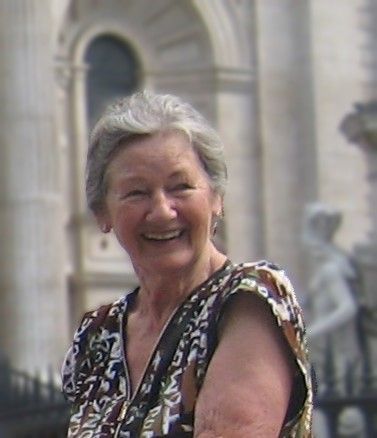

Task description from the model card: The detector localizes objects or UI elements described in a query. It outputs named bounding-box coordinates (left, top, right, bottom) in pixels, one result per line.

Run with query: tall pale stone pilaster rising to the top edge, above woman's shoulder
left=255, top=0, right=318, bottom=284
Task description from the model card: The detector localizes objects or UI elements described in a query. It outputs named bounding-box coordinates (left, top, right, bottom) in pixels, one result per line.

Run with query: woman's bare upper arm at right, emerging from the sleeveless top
left=194, top=293, right=296, bottom=438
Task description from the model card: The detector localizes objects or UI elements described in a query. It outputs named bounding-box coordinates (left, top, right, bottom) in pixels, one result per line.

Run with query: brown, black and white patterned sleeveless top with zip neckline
left=62, top=261, right=313, bottom=438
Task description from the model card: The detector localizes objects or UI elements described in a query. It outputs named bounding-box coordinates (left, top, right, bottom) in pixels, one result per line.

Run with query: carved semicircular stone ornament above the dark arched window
left=59, top=0, right=213, bottom=74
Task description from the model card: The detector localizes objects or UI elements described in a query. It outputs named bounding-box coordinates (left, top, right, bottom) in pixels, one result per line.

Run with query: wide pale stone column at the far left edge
left=0, top=0, right=67, bottom=371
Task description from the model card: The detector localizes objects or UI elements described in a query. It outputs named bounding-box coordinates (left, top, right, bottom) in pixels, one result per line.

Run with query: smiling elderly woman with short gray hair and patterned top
left=63, top=92, right=312, bottom=438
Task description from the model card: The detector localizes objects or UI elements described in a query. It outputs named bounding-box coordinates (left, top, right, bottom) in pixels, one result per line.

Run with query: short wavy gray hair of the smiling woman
left=86, top=91, right=227, bottom=213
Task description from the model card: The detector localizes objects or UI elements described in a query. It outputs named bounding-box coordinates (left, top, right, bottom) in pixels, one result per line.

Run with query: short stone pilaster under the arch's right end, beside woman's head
left=216, top=75, right=265, bottom=261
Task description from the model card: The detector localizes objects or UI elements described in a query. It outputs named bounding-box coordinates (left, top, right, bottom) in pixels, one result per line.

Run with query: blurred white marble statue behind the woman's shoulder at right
left=303, top=203, right=360, bottom=384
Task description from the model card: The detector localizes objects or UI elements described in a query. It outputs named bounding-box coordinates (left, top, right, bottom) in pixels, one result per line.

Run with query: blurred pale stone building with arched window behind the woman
left=0, top=0, right=377, bottom=371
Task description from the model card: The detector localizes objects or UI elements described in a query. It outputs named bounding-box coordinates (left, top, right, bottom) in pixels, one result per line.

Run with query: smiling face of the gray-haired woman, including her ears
left=99, top=133, right=222, bottom=273
